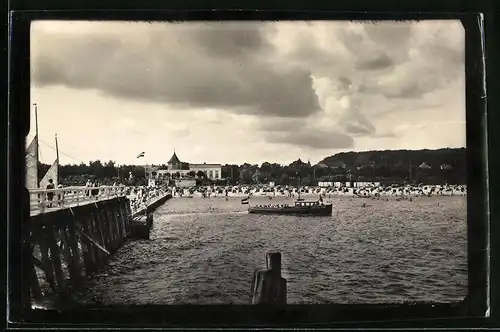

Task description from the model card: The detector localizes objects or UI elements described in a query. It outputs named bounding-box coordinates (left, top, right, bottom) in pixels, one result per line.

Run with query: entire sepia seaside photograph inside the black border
left=26, top=20, right=468, bottom=309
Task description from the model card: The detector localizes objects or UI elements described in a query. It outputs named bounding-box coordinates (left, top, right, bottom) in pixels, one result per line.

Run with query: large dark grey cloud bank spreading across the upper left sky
left=33, top=23, right=320, bottom=117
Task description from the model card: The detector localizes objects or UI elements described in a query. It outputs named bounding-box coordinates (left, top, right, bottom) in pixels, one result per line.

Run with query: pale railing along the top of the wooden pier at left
left=29, top=186, right=128, bottom=214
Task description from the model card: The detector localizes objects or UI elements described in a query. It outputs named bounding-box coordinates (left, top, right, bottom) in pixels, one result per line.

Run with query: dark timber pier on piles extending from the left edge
left=23, top=188, right=171, bottom=303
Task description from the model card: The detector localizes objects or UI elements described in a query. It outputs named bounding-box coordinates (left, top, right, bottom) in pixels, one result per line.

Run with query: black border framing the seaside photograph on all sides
left=4, top=2, right=500, bottom=328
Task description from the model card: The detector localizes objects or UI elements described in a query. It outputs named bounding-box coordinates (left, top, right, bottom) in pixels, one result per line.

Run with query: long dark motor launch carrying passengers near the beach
left=248, top=199, right=333, bottom=216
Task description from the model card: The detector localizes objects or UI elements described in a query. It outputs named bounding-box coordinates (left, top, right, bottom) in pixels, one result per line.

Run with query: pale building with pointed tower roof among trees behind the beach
left=157, top=152, right=222, bottom=180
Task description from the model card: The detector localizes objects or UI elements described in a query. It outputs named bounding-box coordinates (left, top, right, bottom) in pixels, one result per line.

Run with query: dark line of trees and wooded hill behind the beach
left=38, top=148, right=466, bottom=185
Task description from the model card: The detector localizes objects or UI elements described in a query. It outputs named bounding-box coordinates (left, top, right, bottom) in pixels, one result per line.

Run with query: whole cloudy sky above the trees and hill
left=29, top=21, right=465, bottom=164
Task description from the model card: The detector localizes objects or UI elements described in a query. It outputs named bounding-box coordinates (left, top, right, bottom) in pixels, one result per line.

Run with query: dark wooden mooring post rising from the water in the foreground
left=252, top=252, right=286, bottom=305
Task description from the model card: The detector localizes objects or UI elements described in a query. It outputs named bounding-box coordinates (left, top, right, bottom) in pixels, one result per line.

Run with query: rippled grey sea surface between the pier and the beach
left=78, top=196, right=467, bottom=304
